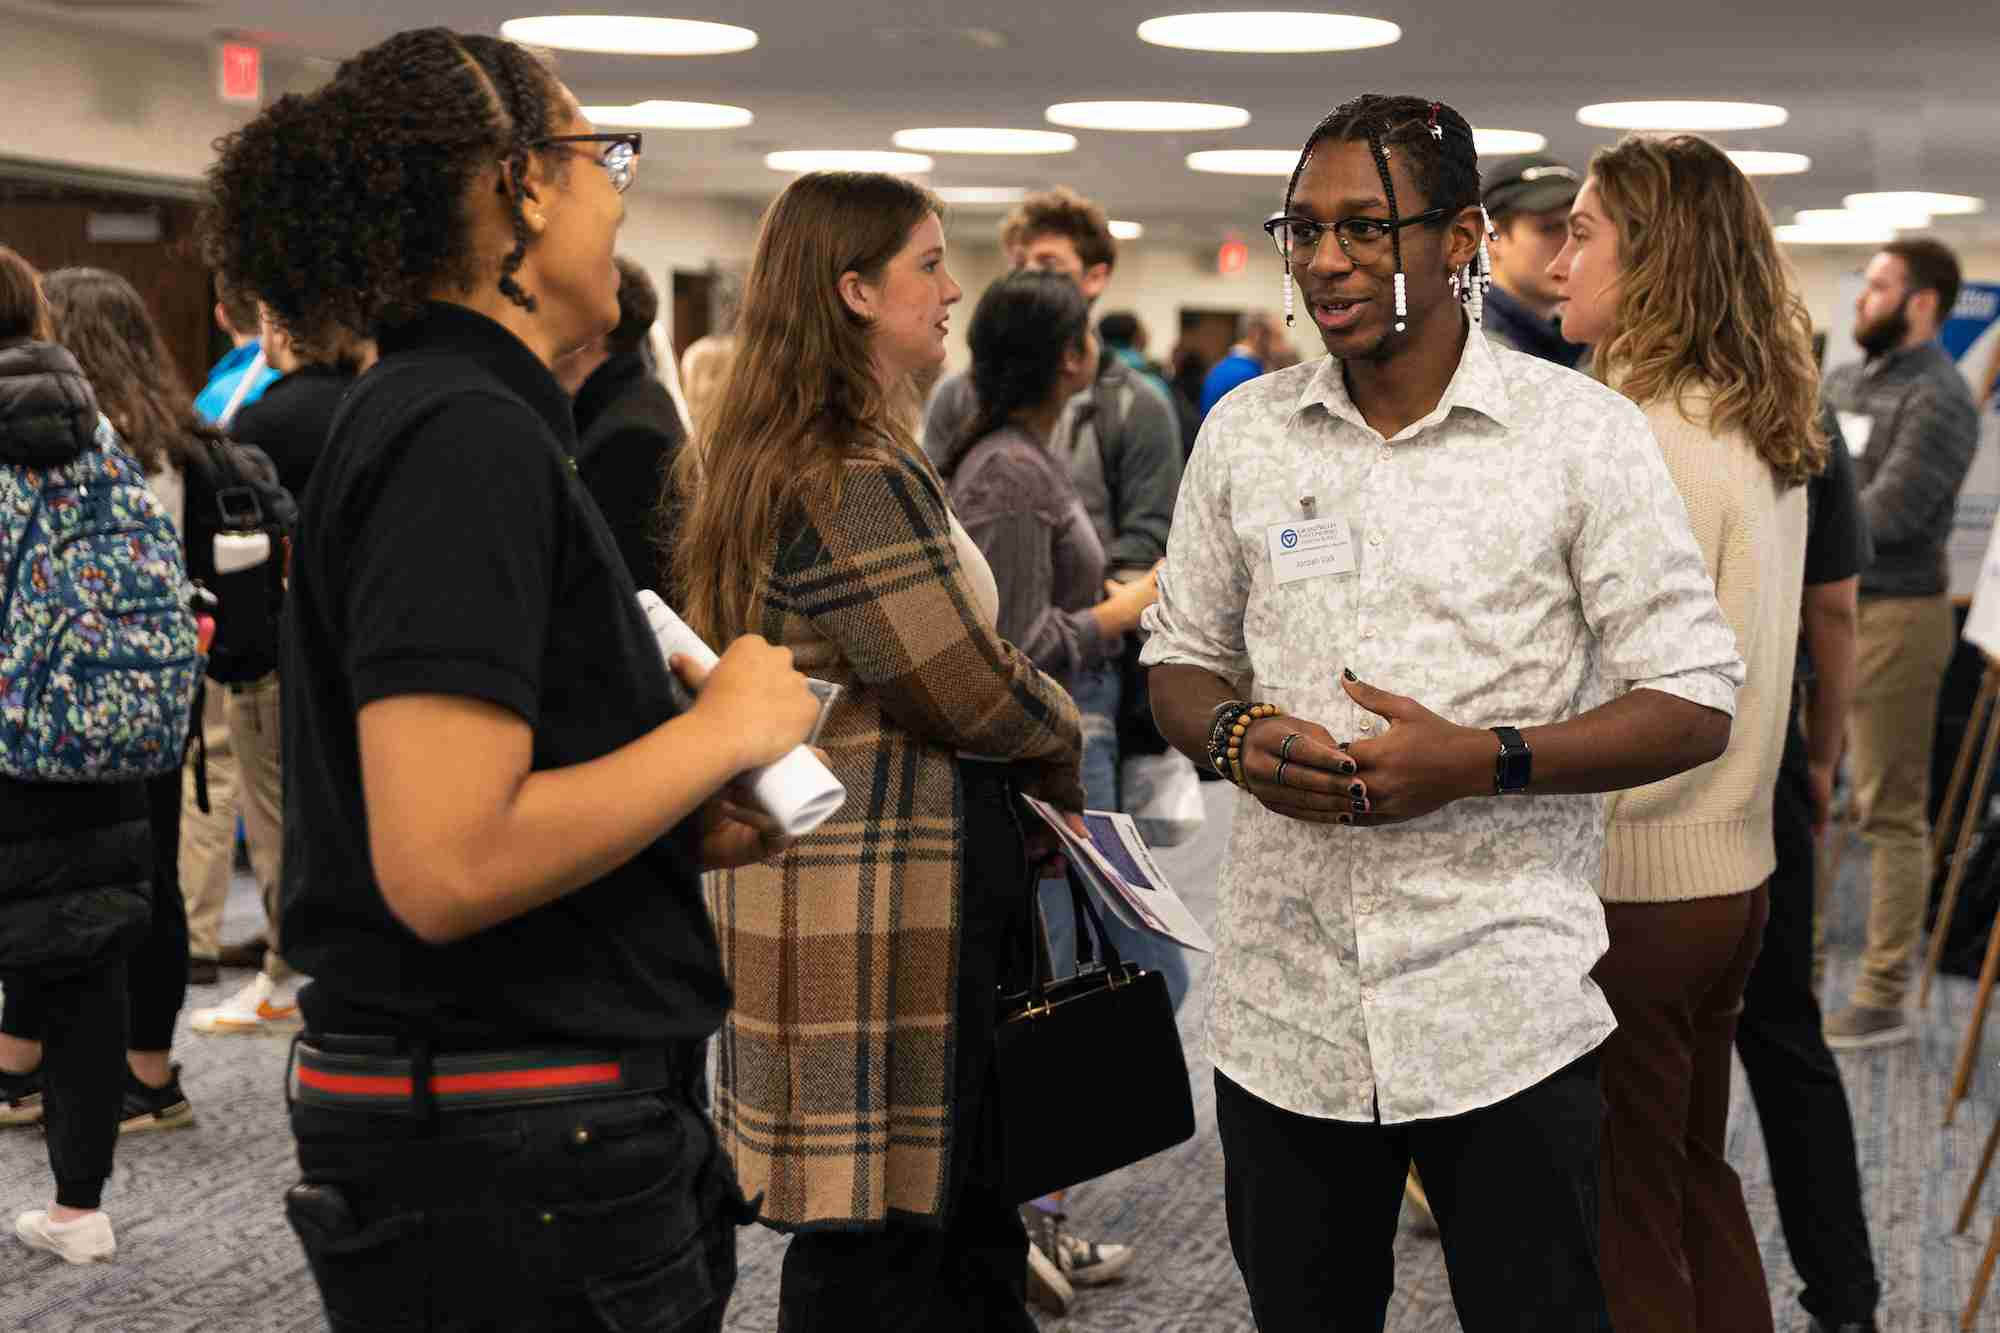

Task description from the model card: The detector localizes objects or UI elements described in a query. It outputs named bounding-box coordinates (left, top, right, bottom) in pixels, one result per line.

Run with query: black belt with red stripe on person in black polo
left=290, top=1037, right=700, bottom=1115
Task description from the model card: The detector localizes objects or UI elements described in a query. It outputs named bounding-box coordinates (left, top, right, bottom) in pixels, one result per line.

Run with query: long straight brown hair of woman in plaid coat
left=664, top=172, right=944, bottom=648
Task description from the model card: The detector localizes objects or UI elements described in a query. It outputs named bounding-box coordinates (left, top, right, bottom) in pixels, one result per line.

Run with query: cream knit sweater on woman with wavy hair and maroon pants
left=1602, top=394, right=1806, bottom=903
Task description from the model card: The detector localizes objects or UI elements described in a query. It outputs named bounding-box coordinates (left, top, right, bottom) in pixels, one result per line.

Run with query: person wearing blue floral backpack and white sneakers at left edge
left=0, top=246, right=202, bottom=1263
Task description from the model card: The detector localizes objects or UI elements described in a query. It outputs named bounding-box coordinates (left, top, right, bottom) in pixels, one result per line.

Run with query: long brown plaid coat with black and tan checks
left=710, top=448, right=1084, bottom=1229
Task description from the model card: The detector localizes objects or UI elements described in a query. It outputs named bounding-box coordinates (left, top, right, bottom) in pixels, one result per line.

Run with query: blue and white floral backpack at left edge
left=0, top=416, right=202, bottom=783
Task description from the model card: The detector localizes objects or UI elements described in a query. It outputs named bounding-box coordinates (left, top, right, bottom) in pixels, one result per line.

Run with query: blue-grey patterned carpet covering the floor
left=11, top=785, right=2000, bottom=1333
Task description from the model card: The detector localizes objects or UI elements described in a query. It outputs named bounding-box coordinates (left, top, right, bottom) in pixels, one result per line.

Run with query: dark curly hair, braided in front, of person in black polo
left=202, top=28, right=566, bottom=356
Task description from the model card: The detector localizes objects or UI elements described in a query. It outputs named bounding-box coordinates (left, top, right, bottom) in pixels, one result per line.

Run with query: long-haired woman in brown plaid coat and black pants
left=676, top=172, right=1082, bottom=1333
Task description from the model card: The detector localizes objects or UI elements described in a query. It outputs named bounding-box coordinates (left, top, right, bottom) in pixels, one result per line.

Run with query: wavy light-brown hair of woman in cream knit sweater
left=1590, top=134, right=1826, bottom=486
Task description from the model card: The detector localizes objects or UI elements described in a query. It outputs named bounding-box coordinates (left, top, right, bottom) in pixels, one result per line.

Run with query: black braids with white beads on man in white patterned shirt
left=1284, top=92, right=1492, bottom=332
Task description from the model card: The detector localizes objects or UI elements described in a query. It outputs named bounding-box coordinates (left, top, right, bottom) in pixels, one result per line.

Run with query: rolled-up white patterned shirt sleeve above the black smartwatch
left=1570, top=408, right=1744, bottom=717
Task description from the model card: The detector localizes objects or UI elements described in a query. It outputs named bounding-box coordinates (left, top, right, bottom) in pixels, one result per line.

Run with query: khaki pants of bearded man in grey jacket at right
left=1848, top=594, right=1954, bottom=1009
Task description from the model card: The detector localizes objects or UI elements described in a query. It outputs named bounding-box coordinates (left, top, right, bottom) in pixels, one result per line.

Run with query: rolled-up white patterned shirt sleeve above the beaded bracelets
left=1140, top=414, right=1250, bottom=681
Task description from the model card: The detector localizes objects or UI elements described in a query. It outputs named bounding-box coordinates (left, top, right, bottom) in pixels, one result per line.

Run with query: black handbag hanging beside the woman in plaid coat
left=994, top=867, right=1194, bottom=1203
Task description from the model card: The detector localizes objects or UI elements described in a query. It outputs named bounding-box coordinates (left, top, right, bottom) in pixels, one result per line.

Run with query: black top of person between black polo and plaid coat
left=574, top=352, right=686, bottom=588
